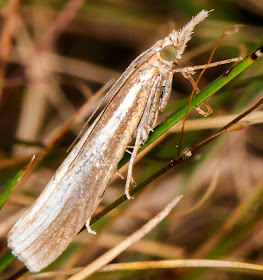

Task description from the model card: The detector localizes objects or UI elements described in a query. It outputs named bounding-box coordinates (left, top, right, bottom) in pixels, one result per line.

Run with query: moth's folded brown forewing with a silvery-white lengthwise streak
left=8, top=59, right=161, bottom=272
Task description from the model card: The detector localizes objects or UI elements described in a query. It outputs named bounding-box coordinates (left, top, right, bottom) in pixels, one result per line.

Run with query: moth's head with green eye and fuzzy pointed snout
left=159, top=10, right=209, bottom=62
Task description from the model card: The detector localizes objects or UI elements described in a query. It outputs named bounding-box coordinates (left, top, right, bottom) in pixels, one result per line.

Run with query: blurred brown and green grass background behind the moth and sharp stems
left=0, top=0, right=263, bottom=279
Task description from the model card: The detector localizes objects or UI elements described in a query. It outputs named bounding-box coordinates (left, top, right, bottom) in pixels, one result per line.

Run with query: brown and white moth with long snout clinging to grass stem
left=8, top=10, right=208, bottom=272
